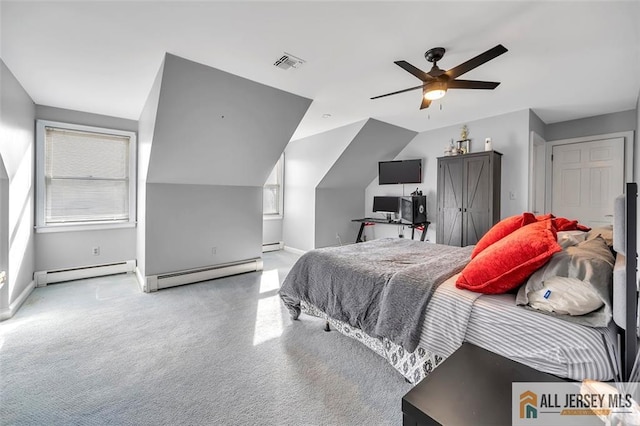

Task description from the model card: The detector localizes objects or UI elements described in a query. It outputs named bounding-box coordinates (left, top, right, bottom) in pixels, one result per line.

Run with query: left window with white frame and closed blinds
left=36, top=120, right=136, bottom=232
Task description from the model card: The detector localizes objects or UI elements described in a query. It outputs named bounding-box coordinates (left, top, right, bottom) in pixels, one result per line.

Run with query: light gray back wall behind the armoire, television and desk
left=365, top=109, right=530, bottom=242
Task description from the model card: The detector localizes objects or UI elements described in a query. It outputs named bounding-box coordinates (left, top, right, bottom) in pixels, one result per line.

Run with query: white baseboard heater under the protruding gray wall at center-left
left=143, top=258, right=262, bottom=292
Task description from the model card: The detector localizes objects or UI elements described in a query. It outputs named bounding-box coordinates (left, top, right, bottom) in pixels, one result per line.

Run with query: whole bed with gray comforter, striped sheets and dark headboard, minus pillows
left=280, top=183, right=637, bottom=383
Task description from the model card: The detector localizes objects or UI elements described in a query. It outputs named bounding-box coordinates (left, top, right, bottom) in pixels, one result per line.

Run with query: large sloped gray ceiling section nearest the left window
left=147, top=54, right=311, bottom=186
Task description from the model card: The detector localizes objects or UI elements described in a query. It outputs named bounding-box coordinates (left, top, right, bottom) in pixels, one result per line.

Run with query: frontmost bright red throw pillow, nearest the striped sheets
left=456, top=220, right=562, bottom=294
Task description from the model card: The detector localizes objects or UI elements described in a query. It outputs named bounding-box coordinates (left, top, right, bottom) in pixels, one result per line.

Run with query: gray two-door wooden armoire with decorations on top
left=436, top=151, right=502, bottom=246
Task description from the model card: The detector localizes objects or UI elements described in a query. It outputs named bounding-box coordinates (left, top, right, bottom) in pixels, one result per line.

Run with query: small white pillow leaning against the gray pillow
left=527, top=276, right=604, bottom=315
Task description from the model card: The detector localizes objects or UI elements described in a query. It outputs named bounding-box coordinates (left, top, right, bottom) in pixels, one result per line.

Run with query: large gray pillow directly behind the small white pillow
left=516, top=236, right=615, bottom=327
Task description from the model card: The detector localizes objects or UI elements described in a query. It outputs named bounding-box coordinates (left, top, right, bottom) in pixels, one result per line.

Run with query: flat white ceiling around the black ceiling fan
left=0, top=0, right=640, bottom=139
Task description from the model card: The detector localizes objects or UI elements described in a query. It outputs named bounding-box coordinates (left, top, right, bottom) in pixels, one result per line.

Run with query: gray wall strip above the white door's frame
left=545, top=110, right=637, bottom=142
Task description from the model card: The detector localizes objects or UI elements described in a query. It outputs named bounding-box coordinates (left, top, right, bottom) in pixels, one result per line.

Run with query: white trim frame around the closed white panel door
left=544, top=130, right=634, bottom=212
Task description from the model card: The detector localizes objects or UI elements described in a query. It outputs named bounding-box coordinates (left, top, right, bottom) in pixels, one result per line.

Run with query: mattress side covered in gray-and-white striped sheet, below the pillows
left=465, top=294, right=618, bottom=380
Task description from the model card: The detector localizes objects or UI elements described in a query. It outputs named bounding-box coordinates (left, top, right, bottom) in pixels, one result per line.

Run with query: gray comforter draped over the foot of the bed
left=280, top=238, right=472, bottom=352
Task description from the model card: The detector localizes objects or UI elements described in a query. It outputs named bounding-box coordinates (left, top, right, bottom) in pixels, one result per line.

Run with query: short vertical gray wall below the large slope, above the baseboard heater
left=145, top=183, right=262, bottom=276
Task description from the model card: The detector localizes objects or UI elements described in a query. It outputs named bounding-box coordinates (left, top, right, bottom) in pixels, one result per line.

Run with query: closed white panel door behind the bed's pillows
left=551, top=138, right=624, bottom=227
